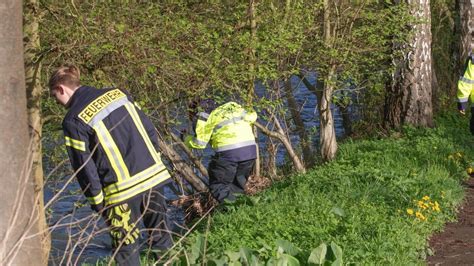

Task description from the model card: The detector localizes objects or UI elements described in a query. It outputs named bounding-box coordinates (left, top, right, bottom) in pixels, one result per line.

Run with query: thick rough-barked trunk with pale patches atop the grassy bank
left=384, top=0, right=433, bottom=128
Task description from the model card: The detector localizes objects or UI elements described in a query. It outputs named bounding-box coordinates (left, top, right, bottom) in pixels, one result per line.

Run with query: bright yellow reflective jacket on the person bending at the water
left=185, top=102, right=257, bottom=159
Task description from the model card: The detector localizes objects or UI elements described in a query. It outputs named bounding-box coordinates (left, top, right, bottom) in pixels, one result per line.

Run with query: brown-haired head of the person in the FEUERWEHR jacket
left=48, top=65, right=81, bottom=107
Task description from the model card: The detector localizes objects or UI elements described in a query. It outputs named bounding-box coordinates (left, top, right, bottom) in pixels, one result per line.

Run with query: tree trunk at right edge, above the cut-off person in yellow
left=459, top=0, right=474, bottom=60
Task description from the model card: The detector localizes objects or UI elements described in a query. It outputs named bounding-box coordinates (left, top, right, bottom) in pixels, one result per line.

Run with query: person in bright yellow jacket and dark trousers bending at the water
left=184, top=99, right=257, bottom=203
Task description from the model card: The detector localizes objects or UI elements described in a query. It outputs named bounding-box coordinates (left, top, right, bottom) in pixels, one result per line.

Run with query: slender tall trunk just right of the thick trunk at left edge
left=24, top=0, right=51, bottom=265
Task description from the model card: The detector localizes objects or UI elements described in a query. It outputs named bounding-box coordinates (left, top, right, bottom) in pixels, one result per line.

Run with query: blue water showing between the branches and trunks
left=45, top=75, right=354, bottom=265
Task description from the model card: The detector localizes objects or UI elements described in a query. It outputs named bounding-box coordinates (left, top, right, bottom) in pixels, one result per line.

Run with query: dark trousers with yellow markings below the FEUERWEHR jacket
left=103, top=185, right=173, bottom=265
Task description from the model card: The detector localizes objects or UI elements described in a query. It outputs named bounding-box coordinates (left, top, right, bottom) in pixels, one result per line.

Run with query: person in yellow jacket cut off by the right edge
left=457, top=51, right=474, bottom=135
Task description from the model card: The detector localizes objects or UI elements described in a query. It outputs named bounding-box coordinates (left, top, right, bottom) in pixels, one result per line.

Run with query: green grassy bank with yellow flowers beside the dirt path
left=174, top=114, right=474, bottom=265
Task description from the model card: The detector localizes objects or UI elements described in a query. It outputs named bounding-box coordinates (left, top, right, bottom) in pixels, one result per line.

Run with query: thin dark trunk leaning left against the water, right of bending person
left=285, top=79, right=314, bottom=167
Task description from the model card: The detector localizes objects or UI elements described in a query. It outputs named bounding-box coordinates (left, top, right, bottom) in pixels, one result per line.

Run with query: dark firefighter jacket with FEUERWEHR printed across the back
left=63, top=86, right=170, bottom=205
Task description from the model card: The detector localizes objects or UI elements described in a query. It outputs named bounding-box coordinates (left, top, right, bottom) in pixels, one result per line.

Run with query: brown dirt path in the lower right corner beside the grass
left=427, top=178, right=474, bottom=265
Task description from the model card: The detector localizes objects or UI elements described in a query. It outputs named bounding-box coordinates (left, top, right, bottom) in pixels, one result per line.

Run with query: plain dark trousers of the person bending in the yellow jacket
left=208, top=157, right=255, bottom=203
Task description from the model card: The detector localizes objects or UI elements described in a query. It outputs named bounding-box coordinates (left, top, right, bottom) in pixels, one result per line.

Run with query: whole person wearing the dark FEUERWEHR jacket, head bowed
left=49, top=66, right=172, bottom=265
